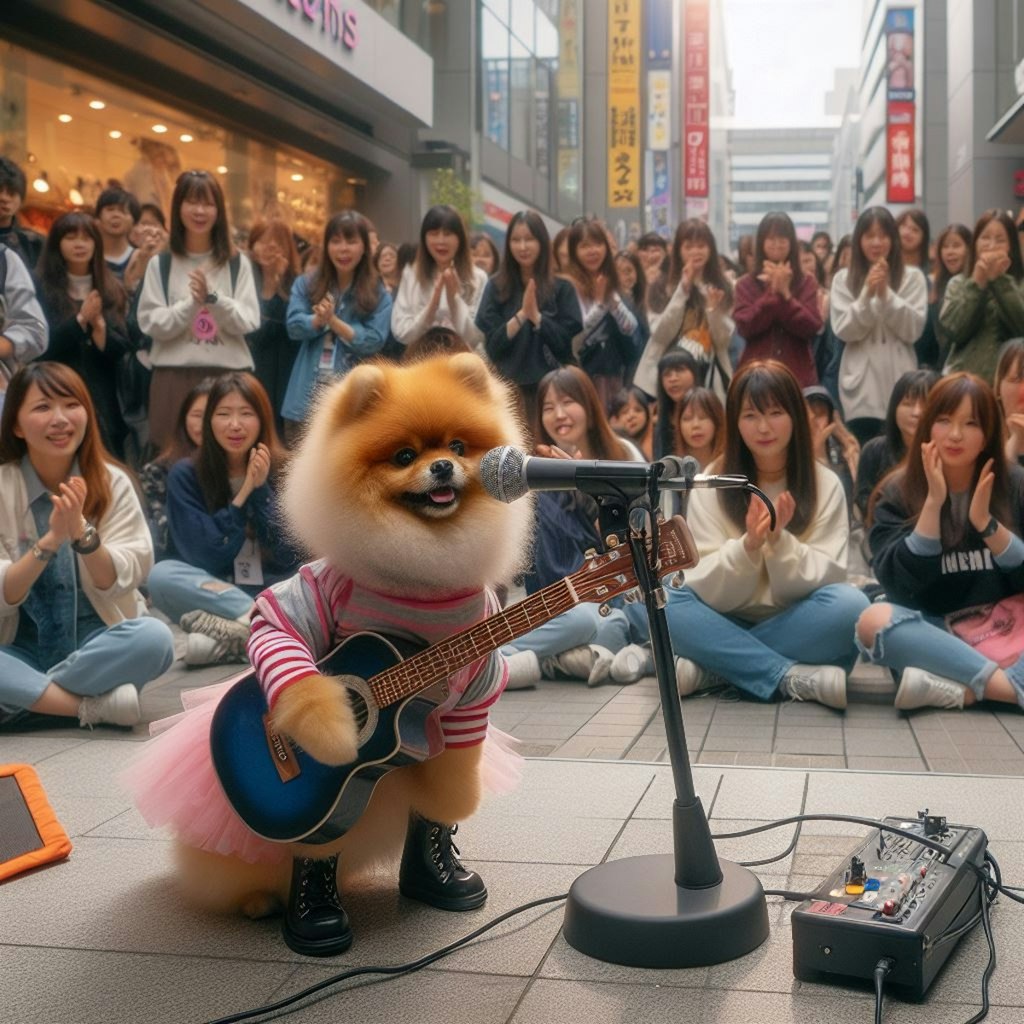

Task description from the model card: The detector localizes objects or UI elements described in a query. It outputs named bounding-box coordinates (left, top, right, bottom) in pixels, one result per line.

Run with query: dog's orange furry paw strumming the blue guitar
left=270, top=676, right=359, bottom=765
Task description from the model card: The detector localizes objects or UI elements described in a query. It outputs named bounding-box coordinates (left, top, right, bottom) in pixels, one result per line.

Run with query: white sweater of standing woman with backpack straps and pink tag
left=138, top=253, right=260, bottom=370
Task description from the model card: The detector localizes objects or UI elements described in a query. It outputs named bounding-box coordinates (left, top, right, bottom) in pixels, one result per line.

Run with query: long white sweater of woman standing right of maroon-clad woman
left=829, top=266, right=928, bottom=420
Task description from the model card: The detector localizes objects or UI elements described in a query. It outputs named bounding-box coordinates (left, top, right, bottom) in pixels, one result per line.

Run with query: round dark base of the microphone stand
left=563, top=854, right=768, bottom=968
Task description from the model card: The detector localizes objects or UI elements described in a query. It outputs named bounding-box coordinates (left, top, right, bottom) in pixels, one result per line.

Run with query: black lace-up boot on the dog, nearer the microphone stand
left=398, top=814, right=487, bottom=910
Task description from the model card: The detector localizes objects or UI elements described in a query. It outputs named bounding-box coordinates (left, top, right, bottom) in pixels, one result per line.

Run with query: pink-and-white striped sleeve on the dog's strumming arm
left=247, top=562, right=344, bottom=709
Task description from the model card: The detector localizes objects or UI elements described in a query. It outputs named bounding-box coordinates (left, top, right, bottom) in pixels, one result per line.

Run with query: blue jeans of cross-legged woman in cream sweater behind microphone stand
left=629, top=583, right=868, bottom=700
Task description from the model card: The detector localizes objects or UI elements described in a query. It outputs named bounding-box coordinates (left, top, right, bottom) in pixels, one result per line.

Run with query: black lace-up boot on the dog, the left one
left=281, top=855, right=352, bottom=956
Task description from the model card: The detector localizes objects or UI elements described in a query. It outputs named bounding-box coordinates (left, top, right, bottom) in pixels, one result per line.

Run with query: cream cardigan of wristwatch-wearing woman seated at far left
left=0, top=462, right=153, bottom=644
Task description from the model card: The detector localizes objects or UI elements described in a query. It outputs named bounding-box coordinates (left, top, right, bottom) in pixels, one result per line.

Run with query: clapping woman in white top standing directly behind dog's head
left=391, top=206, right=487, bottom=349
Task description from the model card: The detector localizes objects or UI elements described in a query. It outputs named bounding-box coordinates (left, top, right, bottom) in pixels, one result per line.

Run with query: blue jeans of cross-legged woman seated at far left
left=0, top=616, right=174, bottom=713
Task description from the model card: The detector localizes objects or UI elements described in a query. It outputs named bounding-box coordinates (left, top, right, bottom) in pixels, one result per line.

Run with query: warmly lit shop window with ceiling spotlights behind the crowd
left=0, top=45, right=366, bottom=241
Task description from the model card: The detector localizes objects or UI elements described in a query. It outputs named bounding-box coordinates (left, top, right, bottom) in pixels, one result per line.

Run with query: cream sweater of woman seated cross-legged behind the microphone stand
left=686, top=463, right=850, bottom=622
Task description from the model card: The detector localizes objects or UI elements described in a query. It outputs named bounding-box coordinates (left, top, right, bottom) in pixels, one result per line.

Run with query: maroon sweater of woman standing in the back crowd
left=732, top=273, right=821, bottom=388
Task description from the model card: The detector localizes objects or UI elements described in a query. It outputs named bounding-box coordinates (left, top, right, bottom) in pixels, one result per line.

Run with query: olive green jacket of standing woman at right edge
left=939, top=273, right=1024, bottom=384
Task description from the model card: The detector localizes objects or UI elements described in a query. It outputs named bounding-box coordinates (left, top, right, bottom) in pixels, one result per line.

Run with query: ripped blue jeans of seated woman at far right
left=857, top=602, right=999, bottom=700
